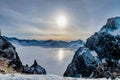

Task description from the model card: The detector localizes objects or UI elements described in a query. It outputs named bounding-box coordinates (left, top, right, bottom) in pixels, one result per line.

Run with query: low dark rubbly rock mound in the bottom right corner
left=93, top=60, right=120, bottom=79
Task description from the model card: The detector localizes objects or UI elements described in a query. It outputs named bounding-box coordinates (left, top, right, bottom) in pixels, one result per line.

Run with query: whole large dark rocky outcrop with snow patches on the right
left=64, top=17, right=120, bottom=78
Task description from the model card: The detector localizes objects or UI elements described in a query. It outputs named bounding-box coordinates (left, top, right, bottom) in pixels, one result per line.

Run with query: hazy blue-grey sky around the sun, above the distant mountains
left=0, top=0, right=120, bottom=40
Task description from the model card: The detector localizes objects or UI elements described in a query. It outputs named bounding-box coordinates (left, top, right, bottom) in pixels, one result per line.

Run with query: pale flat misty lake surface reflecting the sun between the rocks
left=14, top=45, right=75, bottom=76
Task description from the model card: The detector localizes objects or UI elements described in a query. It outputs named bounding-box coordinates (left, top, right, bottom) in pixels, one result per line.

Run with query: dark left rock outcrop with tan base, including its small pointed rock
left=0, top=36, right=46, bottom=74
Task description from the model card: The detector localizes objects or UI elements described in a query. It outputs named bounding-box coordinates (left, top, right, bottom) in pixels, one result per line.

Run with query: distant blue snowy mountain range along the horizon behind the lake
left=3, top=36, right=84, bottom=50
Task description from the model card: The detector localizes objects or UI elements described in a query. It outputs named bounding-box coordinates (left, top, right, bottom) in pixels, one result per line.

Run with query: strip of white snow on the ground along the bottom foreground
left=0, top=74, right=109, bottom=80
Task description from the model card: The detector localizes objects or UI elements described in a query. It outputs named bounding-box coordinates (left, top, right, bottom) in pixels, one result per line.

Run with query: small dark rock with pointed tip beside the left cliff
left=24, top=60, right=46, bottom=74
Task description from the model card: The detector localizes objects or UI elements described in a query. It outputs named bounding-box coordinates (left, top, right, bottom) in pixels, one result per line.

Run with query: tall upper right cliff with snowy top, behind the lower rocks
left=86, top=17, right=120, bottom=60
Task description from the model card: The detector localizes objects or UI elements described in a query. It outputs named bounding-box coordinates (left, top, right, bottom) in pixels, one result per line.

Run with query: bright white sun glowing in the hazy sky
left=56, top=15, right=67, bottom=28
